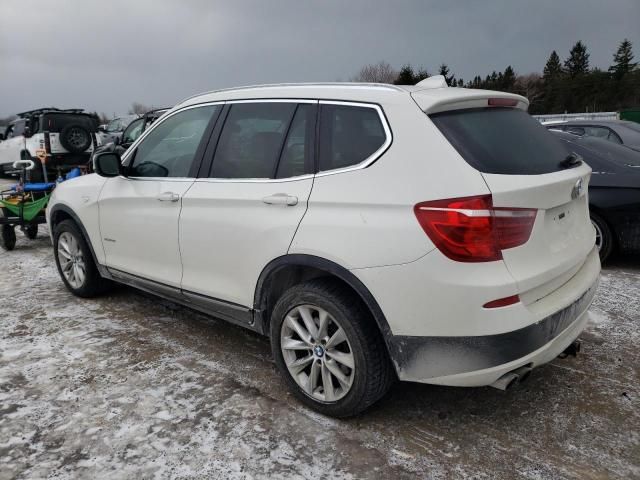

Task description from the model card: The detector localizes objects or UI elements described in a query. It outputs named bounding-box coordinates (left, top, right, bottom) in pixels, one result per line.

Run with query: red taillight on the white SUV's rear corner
left=413, top=195, right=537, bottom=262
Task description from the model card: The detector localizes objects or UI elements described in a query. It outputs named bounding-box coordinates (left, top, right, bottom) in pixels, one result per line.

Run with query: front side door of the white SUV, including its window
left=99, top=104, right=222, bottom=288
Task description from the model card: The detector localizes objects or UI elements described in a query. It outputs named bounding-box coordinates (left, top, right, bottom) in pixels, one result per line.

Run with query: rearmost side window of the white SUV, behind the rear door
left=319, top=104, right=387, bottom=172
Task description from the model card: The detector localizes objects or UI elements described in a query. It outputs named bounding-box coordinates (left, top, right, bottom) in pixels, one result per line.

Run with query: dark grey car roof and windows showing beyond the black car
left=544, top=120, right=640, bottom=151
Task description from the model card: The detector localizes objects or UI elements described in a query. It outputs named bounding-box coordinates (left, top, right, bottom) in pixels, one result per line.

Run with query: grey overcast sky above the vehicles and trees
left=0, top=0, right=640, bottom=116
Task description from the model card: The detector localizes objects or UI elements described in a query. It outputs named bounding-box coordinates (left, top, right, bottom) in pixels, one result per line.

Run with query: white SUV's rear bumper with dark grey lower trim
left=380, top=250, right=600, bottom=386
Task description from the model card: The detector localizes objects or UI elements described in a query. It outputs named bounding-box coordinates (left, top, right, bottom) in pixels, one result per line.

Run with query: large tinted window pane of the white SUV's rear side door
left=210, top=102, right=297, bottom=178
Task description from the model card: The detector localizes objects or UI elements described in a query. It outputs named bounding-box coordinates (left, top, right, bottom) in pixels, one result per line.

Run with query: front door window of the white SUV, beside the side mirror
left=129, top=105, right=220, bottom=177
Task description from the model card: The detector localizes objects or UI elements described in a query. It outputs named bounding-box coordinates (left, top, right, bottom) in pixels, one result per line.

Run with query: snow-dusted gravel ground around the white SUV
left=0, top=218, right=640, bottom=479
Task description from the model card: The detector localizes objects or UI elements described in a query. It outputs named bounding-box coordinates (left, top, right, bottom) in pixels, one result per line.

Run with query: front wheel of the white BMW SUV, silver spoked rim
left=53, top=220, right=109, bottom=298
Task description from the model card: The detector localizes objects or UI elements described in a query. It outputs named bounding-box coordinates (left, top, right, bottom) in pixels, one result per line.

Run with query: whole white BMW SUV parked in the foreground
left=47, top=77, right=600, bottom=417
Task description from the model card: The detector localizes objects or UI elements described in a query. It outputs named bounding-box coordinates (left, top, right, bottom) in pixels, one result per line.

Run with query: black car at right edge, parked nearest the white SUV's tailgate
left=550, top=130, right=640, bottom=262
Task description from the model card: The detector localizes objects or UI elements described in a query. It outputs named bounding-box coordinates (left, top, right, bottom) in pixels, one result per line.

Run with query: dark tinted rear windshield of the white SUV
left=430, top=108, right=570, bottom=175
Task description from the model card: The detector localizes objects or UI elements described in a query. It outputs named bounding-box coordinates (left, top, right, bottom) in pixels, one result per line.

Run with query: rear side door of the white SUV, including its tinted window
left=180, top=100, right=317, bottom=307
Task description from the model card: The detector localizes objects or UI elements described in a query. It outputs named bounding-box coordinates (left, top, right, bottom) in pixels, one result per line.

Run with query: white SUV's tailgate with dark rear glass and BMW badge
left=429, top=103, right=595, bottom=298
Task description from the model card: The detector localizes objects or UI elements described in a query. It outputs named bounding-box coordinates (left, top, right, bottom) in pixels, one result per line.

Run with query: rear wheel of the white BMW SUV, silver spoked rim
left=270, top=279, right=395, bottom=418
